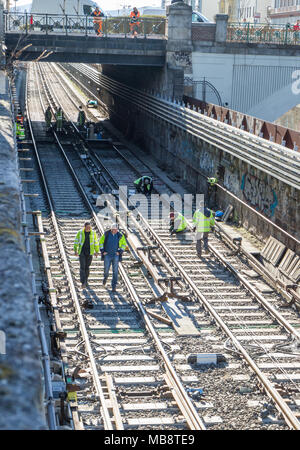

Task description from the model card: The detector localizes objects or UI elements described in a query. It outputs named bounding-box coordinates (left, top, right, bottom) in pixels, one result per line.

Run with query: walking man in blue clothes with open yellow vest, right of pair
left=100, top=223, right=127, bottom=292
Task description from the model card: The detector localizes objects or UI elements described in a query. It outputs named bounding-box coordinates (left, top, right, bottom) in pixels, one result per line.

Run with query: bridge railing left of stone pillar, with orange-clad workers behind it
left=4, top=12, right=166, bottom=38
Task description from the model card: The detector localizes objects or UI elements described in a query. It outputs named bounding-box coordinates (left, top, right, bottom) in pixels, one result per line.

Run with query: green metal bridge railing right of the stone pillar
left=227, top=23, right=300, bottom=45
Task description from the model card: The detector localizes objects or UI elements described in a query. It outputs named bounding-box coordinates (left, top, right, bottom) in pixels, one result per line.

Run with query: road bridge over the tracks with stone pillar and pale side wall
left=2, top=2, right=300, bottom=122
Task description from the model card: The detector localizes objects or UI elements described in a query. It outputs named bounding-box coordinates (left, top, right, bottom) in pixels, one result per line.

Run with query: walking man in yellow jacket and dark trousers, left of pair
left=74, top=222, right=99, bottom=289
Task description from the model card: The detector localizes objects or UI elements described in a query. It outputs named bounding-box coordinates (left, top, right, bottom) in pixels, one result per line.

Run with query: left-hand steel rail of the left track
left=27, top=63, right=113, bottom=430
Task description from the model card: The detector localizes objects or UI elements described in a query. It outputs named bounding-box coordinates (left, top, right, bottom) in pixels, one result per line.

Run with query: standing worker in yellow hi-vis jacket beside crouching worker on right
left=193, top=201, right=215, bottom=258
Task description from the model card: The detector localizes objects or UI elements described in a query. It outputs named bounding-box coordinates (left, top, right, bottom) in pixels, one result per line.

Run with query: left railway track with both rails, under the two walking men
left=23, top=61, right=212, bottom=429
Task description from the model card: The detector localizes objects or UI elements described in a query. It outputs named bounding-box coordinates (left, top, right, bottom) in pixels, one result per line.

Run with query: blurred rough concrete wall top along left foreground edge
left=0, top=72, right=45, bottom=429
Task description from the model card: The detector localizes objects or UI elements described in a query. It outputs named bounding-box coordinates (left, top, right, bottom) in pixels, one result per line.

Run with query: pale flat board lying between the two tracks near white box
left=162, top=299, right=200, bottom=336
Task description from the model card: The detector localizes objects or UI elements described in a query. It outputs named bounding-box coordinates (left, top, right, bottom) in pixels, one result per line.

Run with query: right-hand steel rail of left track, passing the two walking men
left=34, top=61, right=206, bottom=430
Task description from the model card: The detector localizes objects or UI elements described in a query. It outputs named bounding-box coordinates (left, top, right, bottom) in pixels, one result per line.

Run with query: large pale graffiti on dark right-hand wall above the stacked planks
left=241, top=173, right=278, bottom=217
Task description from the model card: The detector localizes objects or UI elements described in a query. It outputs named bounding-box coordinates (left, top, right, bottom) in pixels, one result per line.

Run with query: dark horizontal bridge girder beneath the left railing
left=5, top=33, right=166, bottom=67
